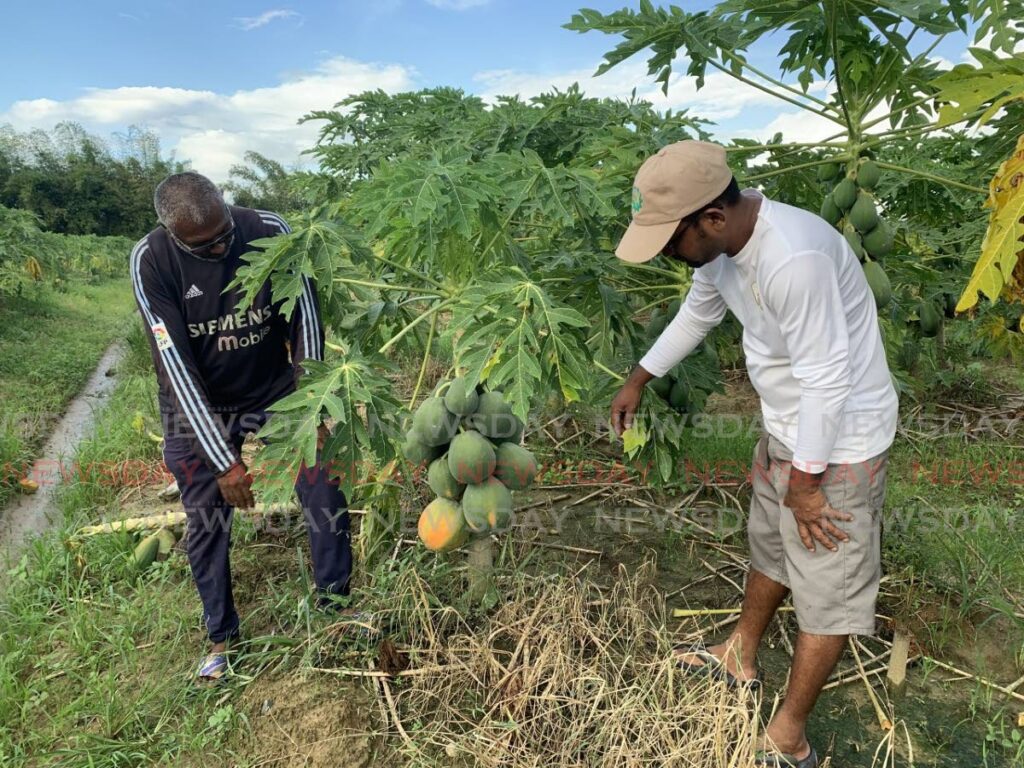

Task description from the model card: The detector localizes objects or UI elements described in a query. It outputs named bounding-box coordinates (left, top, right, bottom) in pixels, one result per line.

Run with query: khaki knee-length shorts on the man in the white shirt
left=746, top=435, right=889, bottom=635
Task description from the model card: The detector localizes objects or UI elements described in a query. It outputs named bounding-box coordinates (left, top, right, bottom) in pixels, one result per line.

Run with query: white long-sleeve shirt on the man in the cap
left=640, top=190, right=898, bottom=473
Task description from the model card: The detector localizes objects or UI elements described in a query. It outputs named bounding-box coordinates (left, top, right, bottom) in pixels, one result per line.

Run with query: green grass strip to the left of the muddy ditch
left=0, top=280, right=135, bottom=505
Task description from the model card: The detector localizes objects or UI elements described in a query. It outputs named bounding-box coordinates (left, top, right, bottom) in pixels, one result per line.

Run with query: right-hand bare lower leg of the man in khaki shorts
left=765, top=632, right=847, bottom=760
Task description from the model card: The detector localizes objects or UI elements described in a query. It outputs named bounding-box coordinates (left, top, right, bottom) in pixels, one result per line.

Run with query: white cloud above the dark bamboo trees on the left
left=0, top=57, right=417, bottom=181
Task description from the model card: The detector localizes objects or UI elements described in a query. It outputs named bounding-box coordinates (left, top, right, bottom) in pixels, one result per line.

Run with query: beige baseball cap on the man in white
left=615, top=139, right=732, bottom=263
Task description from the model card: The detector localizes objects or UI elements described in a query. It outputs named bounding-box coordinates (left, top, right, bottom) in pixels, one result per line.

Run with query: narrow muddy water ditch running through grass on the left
left=0, top=344, right=124, bottom=563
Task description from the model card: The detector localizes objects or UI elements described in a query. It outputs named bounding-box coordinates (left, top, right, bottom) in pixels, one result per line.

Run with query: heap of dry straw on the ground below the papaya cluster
left=368, top=567, right=757, bottom=768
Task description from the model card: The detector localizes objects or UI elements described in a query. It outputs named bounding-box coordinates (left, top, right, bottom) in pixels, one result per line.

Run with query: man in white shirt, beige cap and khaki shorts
left=611, top=141, right=897, bottom=768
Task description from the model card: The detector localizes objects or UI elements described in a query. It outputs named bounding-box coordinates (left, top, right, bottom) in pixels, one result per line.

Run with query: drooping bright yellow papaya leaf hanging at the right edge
left=956, top=134, right=1024, bottom=312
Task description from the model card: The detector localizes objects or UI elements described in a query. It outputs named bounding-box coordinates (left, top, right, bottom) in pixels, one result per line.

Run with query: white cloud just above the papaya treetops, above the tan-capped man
left=473, top=61, right=824, bottom=121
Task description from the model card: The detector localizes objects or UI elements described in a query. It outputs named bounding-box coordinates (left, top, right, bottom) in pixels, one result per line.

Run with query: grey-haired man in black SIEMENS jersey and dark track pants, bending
left=131, top=172, right=351, bottom=679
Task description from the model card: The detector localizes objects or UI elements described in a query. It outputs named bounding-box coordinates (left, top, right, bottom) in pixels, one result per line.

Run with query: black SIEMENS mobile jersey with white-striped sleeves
left=131, top=206, right=324, bottom=474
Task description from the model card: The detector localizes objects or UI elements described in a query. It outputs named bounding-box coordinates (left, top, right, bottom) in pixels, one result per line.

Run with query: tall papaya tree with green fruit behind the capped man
left=566, top=0, right=1024, bottom=403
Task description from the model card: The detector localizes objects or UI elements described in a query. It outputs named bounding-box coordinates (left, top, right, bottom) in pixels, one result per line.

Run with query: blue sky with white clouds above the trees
left=0, top=0, right=965, bottom=180
